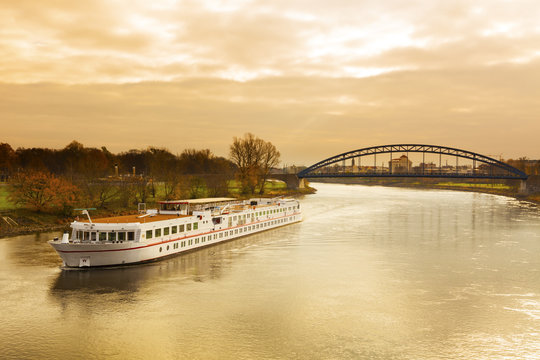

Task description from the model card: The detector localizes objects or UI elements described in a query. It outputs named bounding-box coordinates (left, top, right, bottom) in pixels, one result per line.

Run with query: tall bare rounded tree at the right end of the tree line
left=229, top=133, right=280, bottom=194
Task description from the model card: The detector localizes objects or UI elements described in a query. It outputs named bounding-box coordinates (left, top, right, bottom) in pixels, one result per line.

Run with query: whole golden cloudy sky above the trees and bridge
left=0, top=0, right=540, bottom=165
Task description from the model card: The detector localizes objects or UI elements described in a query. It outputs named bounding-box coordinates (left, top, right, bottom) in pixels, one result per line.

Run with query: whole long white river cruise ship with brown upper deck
left=49, top=198, right=302, bottom=268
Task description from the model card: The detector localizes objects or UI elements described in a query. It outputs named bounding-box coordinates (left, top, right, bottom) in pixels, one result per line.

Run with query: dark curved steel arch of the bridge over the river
left=297, top=144, right=528, bottom=180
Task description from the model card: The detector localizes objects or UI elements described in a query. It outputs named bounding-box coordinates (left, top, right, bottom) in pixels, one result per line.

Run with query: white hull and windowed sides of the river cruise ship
left=50, top=200, right=302, bottom=267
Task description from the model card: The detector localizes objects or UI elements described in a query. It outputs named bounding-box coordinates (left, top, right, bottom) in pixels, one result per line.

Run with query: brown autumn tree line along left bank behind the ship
left=0, top=133, right=280, bottom=214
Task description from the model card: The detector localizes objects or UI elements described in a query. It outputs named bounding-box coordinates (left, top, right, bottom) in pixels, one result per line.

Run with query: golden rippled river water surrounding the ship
left=0, top=184, right=540, bottom=359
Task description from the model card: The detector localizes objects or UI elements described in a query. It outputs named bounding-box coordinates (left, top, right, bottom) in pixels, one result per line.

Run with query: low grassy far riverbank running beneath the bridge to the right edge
left=312, top=178, right=540, bottom=205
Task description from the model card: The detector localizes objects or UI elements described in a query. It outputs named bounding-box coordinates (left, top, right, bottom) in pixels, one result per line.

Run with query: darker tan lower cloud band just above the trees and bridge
left=0, top=62, right=540, bottom=164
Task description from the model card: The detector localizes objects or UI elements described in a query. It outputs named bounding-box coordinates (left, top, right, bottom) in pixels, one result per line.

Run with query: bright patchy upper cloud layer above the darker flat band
left=0, top=0, right=540, bottom=83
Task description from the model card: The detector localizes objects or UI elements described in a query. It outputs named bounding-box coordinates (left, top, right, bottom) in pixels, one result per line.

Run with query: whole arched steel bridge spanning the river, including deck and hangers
left=297, top=144, right=528, bottom=180
